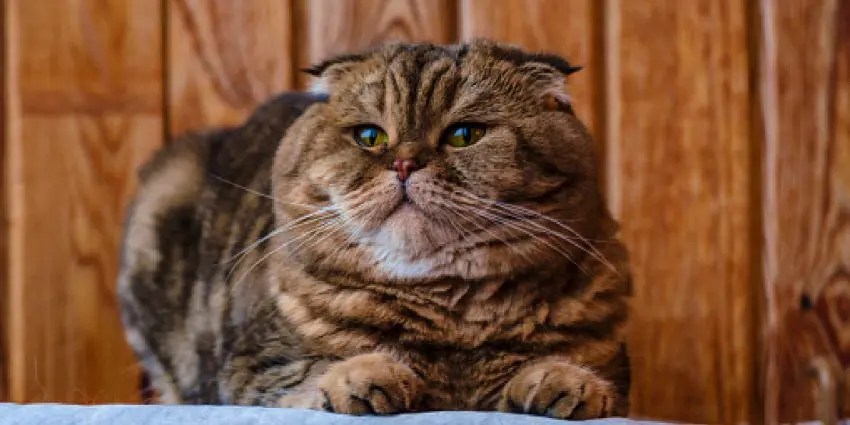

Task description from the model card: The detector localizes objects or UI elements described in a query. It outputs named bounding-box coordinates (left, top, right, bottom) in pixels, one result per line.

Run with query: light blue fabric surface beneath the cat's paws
left=0, top=404, right=664, bottom=425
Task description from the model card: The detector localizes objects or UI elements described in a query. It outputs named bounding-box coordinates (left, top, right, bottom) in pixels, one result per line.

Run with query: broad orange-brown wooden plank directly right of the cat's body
left=606, top=0, right=759, bottom=423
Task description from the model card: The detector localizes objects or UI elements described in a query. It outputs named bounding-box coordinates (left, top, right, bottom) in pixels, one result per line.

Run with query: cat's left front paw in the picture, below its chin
left=318, top=353, right=423, bottom=415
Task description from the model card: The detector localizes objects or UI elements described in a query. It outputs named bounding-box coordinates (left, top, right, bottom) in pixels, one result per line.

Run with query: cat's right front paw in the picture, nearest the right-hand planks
left=499, top=361, right=616, bottom=419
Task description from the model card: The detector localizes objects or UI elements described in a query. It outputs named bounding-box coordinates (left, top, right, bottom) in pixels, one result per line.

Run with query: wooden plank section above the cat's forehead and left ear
left=299, top=0, right=456, bottom=87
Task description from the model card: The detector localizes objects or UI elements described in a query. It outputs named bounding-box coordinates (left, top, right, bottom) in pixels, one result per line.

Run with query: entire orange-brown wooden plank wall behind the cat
left=0, top=0, right=850, bottom=423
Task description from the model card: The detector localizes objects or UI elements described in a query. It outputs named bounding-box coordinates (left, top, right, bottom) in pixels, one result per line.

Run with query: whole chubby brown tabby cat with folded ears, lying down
left=118, top=40, right=631, bottom=419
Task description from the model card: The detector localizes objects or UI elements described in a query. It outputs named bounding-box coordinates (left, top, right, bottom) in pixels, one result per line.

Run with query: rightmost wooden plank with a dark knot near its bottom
left=760, top=0, right=850, bottom=423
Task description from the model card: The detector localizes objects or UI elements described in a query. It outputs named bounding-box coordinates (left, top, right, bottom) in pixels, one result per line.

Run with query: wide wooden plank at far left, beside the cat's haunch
left=6, top=0, right=163, bottom=403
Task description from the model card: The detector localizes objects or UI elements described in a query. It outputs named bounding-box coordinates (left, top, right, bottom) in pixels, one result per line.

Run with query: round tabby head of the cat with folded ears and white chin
left=273, top=42, right=600, bottom=280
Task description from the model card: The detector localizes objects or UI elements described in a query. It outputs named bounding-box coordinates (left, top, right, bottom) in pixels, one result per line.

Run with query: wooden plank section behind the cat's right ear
left=459, top=0, right=604, bottom=142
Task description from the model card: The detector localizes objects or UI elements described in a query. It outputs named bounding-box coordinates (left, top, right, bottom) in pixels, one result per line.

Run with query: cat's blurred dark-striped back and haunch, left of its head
left=118, top=93, right=323, bottom=402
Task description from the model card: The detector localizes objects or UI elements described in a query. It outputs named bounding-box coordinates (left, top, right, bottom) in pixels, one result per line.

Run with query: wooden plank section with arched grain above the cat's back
left=166, top=0, right=294, bottom=135
